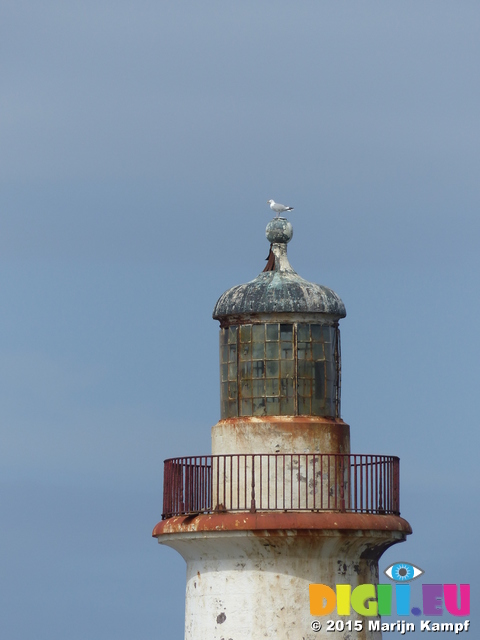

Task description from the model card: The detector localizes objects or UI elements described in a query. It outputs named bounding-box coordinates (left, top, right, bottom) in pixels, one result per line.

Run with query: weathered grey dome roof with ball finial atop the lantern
left=213, top=218, right=346, bottom=320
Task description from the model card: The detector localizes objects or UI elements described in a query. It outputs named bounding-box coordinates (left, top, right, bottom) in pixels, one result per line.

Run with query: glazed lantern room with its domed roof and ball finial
left=213, top=218, right=346, bottom=419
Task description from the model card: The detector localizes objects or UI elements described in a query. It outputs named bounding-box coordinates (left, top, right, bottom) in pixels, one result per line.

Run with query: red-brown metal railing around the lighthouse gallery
left=162, top=453, right=400, bottom=519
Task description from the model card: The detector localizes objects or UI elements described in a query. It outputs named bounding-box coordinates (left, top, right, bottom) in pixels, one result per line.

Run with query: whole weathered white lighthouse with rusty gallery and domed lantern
left=153, top=218, right=411, bottom=640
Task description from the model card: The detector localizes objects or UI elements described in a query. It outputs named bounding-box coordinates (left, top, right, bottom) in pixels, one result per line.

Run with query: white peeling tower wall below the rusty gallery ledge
left=158, top=530, right=404, bottom=640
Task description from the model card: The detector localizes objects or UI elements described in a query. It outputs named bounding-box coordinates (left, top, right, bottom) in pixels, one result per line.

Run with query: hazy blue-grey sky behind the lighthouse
left=0, top=0, right=480, bottom=640
